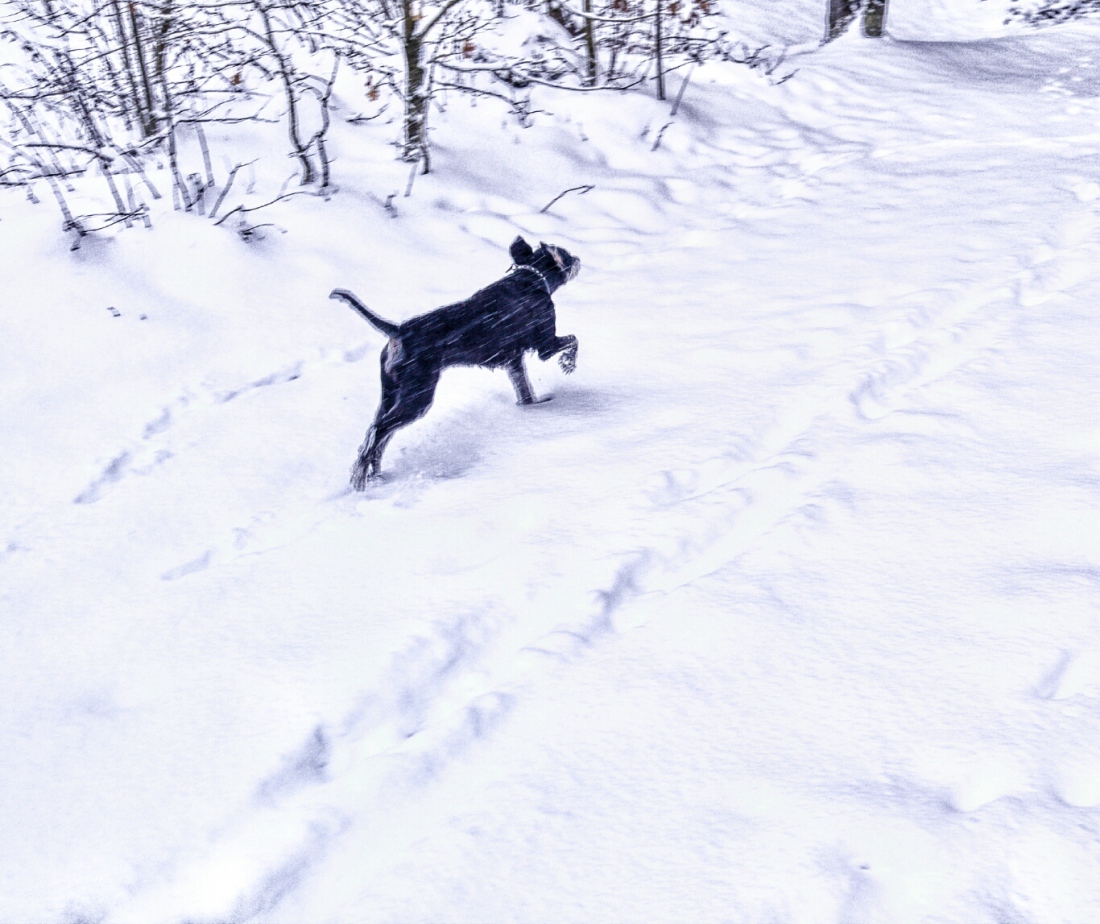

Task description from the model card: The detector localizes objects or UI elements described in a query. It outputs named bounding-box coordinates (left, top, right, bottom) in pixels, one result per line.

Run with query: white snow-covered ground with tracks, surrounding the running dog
left=0, top=0, right=1100, bottom=924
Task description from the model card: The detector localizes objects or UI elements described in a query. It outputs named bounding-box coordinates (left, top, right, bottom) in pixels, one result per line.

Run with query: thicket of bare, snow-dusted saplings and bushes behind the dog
left=0, top=0, right=800, bottom=240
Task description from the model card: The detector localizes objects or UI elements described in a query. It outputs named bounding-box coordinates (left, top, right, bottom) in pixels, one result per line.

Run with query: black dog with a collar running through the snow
left=329, top=238, right=581, bottom=491
